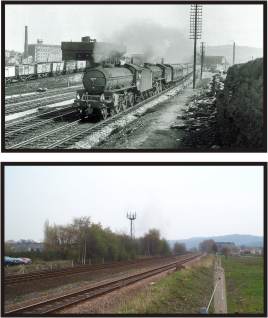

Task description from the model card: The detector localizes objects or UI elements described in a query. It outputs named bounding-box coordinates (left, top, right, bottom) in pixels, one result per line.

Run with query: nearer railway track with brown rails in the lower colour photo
left=5, top=254, right=200, bottom=316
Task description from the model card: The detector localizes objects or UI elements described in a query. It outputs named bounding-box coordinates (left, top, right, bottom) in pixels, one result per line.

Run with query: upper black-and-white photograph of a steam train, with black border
left=1, top=1, right=267, bottom=152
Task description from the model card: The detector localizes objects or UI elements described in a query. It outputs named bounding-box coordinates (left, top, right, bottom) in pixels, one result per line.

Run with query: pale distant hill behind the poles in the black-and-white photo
left=206, top=44, right=263, bottom=64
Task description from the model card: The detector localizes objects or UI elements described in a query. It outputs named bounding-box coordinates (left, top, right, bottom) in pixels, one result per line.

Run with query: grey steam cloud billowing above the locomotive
left=94, top=21, right=193, bottom=63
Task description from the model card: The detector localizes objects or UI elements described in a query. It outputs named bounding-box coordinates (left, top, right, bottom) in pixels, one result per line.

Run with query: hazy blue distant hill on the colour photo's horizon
left=168, top=234, right=263, bottom=249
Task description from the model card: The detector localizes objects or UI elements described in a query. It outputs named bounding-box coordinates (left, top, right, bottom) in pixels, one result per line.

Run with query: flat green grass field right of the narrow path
left=222, top=256, right=264, bottom=314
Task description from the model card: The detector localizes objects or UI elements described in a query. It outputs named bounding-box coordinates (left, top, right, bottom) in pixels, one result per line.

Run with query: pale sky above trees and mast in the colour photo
left=5, top=166, right=263, bottom=241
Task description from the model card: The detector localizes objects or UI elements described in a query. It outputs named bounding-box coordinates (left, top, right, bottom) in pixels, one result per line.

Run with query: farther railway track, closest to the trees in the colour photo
left=4, top=257, right=169, bottom=286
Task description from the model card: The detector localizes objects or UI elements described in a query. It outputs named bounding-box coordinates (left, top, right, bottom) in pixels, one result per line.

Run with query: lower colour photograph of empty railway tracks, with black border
left=1, top=162, right=267, bottom=317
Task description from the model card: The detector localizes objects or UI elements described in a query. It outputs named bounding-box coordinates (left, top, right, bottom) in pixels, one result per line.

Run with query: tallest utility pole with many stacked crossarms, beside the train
left=190, top=4, right=202, bottom=88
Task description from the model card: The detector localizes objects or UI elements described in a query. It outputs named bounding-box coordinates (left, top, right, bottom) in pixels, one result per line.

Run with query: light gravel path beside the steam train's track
left=97, top=88, right=194, bottom=149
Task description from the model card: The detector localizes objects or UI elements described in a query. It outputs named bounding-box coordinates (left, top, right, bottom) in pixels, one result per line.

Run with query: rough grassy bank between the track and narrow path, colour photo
left=117, top=256, right=213, bottom=314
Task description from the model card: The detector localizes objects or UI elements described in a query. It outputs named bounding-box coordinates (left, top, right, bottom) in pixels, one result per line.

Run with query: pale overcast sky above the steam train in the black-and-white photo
left=5, top=4, right=263, bottom=51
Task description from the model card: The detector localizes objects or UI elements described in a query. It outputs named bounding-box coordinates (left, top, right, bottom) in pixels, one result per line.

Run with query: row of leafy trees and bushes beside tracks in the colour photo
left=43, top=217, right=172, bottom=264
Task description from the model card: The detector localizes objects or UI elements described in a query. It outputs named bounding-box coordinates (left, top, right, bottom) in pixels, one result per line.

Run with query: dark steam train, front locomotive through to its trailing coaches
left=74, top=63, right=193, bottom=119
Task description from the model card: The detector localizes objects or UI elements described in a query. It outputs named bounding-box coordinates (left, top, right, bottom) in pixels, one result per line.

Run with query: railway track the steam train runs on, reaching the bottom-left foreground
left=7, top=79, right=191, bottom=149
